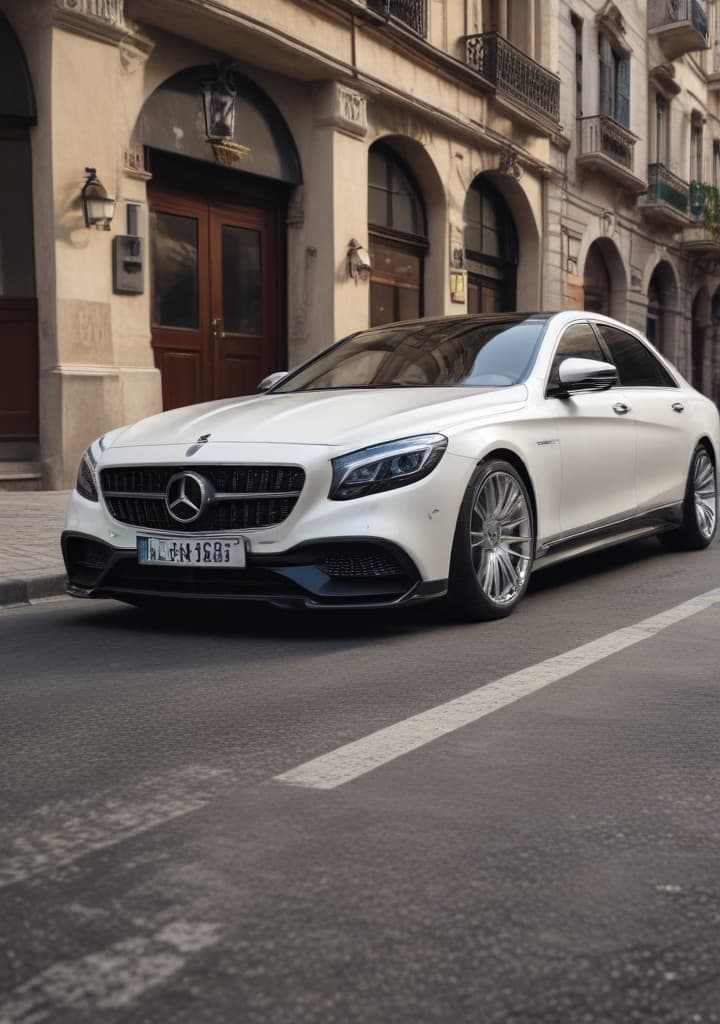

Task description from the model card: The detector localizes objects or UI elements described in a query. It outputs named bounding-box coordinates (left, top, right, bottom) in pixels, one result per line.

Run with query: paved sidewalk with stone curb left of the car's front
left=0, top=490, right=69, bottom=607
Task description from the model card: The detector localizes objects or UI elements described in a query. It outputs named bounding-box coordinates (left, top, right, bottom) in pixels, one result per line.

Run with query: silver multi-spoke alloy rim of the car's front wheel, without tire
left=470, top=471, right=533, bottom=604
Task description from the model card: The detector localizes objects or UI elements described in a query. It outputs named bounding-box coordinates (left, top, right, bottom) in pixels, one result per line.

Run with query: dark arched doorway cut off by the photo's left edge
left=0, top=13, right=38, bottom=444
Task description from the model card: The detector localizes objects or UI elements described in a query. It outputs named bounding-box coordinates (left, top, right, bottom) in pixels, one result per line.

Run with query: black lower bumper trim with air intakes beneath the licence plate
left=62, top=530, right=448, bottom=608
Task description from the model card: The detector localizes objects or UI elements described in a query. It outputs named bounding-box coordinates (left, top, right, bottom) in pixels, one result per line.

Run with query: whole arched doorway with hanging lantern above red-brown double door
left=136, top=66, right=302, bottom=409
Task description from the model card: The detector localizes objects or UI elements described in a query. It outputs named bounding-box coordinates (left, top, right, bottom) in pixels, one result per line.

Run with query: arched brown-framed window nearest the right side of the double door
left=368, top=143, right=427, bottom=327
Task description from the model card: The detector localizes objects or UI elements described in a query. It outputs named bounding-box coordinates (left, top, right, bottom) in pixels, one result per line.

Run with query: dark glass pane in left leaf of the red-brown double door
left=151, top=212, right=198, bottom=331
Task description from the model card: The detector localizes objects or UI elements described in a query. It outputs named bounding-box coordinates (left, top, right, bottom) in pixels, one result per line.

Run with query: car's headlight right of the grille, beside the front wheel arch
left=328, top=434, right=448, bottom=502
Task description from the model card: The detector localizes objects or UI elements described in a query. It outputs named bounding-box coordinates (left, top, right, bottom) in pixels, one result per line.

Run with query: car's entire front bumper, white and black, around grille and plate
left=62, top=444, right=474, bottom=607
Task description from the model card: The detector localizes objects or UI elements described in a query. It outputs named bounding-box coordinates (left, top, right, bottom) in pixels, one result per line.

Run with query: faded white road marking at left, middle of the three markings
left=0, top=765, right=229, bottom=889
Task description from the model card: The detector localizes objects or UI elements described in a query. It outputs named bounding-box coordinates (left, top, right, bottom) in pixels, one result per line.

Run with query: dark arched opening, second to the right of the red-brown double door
left=463, top=175, right=517, bottom=313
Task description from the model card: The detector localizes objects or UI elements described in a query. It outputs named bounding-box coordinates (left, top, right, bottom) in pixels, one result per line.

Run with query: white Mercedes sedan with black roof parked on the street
left=62, top=312, right=720, bottom=620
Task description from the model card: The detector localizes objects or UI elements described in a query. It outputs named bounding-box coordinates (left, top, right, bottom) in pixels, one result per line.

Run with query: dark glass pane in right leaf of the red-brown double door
left=222, top=224, right=262, bottom=335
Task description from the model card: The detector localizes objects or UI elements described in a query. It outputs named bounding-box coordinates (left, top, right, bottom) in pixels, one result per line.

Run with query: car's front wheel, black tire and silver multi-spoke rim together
left=447, top=459, right=536, bottom=622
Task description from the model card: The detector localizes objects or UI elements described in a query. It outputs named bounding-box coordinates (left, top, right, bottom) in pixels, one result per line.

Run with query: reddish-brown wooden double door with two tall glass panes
left=150, top=186, right=286, bottom=409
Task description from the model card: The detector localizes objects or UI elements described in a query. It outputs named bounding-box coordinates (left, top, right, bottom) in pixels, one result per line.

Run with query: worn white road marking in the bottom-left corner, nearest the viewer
left=0, top=921, right=220, bottom=1024
